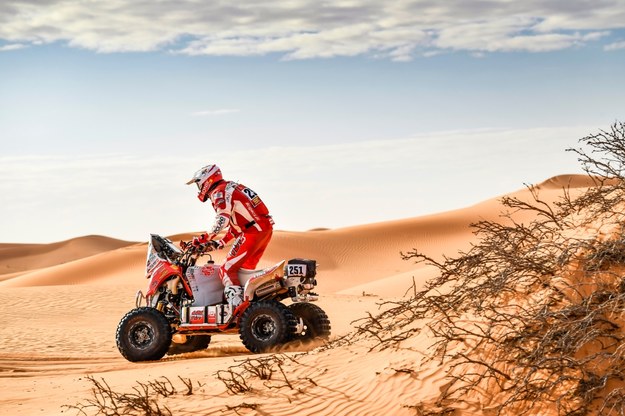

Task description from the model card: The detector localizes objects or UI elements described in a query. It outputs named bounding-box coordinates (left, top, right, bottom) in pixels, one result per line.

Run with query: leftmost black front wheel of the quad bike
left=116, top=307, right=171, bottom=362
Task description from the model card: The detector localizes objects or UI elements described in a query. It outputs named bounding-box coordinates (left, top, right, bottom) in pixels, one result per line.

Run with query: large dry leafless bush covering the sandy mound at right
left=342, top=123, right=625, bottom=416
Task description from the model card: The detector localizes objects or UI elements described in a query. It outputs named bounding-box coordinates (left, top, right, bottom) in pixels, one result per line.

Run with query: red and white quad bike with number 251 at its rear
left=116, top=234, right=330, bottom=361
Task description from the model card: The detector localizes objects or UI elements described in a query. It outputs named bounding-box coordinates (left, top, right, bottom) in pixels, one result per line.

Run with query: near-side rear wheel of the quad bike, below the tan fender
left=239, top=300, right=297, bottom=353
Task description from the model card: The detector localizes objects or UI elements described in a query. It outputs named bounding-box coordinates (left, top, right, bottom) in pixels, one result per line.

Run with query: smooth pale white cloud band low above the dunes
left=0, top=127, right=596, bottom=242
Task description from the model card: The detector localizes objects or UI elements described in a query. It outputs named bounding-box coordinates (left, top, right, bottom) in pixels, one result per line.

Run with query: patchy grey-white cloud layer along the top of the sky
left=0, top=0, right=625, bottom=61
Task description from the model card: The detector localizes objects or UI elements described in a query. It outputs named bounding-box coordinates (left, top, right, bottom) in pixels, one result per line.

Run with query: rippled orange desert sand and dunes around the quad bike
left=0, top=175, right=604, bottom=415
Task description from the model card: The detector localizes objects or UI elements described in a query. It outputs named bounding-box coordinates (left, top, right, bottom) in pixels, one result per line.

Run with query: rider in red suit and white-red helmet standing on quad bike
left=187, top=165, right=273, bottom=307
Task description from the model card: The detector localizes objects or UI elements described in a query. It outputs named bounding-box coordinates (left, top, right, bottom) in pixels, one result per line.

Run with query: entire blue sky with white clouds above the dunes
left=0, top=0, right=625, bottom=243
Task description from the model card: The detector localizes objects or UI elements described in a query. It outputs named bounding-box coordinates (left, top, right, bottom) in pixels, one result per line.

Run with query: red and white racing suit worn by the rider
left=208, top=181, right=273, bottom=286
